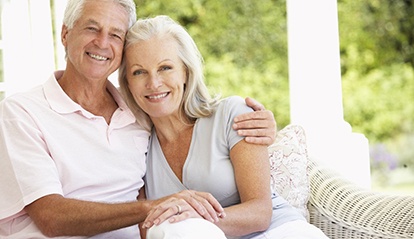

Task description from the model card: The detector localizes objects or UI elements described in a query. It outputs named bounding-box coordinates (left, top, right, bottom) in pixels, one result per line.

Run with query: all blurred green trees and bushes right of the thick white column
left=338, top=0, right=414, bottom=141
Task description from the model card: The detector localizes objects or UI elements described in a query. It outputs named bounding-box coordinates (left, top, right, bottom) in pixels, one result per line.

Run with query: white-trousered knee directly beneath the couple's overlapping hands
left=147, top=218, right=226, bottom=239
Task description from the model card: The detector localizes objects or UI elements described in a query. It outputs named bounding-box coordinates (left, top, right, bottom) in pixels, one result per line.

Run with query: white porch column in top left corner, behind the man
left=2, top=0, right=55, bottom=96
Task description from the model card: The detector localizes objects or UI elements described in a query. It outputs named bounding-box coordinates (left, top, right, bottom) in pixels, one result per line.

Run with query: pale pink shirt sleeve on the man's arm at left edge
left=0, top=96, right=62, bottom=219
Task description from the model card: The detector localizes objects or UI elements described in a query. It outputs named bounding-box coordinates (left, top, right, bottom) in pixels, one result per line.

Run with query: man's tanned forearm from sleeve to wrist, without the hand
left=25, top=194, right=151, bottom=237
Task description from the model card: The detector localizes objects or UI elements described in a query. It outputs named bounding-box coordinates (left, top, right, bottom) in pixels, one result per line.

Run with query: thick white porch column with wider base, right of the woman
left=287, top=0, right=371, bottom=187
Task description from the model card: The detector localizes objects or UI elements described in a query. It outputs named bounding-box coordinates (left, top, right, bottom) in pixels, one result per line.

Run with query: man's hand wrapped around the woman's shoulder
left=233, top=97, right=277, bottom=145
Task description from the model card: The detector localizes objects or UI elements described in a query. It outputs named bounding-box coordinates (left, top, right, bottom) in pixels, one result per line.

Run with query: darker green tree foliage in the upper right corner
left=338, top=0, right=414, bottom=71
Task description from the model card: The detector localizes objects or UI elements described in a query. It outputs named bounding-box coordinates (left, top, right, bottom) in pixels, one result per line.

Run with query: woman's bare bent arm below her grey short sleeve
left=217, top=140, right=272, bottom=236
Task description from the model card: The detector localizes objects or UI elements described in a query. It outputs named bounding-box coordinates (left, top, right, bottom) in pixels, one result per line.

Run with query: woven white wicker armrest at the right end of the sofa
left=308, top=159, right=414, bottom=239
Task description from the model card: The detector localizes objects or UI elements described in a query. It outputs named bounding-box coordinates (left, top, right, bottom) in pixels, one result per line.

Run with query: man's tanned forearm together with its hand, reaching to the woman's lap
left=25, top=191, right=223, bottom=237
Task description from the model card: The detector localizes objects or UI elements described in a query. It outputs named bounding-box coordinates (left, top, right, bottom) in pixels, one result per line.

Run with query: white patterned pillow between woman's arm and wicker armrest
left=268, top=125, right=310, bottom=218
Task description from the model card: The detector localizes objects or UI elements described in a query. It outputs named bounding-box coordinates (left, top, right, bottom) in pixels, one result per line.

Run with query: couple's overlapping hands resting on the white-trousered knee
left=143, top=190, right=225, bottom=228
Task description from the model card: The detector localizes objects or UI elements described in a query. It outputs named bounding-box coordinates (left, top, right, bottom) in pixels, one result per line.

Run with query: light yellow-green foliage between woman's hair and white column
left=206, top=55, right=289, bottom=125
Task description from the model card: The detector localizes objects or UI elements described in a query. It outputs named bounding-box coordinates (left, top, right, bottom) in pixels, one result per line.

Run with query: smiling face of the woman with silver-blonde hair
left=125, top=36, right=186, bottom=120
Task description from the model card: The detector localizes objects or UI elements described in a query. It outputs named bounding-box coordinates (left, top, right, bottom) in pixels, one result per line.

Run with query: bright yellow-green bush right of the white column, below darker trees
left=342, top=64, right=414, bottom=143
